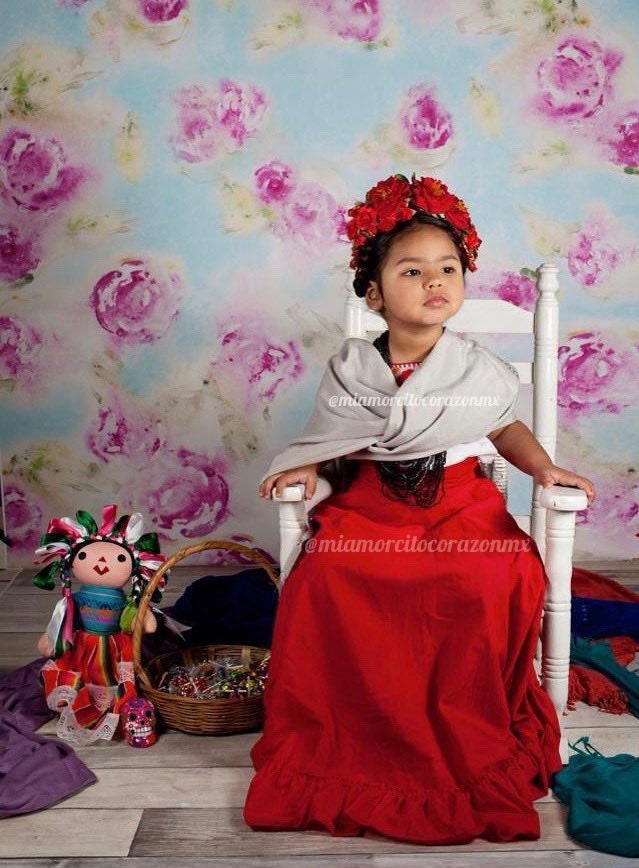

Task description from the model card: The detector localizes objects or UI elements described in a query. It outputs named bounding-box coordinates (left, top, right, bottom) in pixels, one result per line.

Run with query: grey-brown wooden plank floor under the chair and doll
left=0, top=560, right=639, bottom=868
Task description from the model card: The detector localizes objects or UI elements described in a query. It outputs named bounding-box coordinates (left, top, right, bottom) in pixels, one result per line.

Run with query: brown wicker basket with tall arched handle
left=133, top=540, right=280, bottom=735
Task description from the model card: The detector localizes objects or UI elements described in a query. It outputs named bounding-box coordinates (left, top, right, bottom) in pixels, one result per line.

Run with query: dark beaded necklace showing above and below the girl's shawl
left=373, top=330, right=446, bottom=507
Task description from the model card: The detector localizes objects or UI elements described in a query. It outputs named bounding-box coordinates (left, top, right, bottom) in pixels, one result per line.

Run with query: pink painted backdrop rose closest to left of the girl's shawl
left=214, top=316, right=304, bottom=400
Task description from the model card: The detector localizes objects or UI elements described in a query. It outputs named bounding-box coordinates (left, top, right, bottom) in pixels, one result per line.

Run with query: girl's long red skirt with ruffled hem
left=244, top=458, right=562, bottom=844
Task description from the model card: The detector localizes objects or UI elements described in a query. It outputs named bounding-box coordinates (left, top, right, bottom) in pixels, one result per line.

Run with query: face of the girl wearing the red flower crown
left=366, top=224, right=464, bottom=329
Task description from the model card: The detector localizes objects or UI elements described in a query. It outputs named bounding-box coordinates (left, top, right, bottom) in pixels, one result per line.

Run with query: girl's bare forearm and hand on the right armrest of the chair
left=488, top=420, right=595, bottom=506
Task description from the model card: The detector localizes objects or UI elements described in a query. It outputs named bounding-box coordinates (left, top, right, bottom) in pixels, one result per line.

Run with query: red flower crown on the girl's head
left=346, top=175, right=481, bottom=271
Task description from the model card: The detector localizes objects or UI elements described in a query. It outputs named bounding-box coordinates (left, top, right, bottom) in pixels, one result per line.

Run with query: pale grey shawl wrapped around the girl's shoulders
left=260, top=327, right=519, bottom=482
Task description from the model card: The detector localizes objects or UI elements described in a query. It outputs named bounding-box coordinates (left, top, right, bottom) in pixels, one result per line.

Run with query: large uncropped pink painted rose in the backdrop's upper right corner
left=536, top=36, right=623, bottom=120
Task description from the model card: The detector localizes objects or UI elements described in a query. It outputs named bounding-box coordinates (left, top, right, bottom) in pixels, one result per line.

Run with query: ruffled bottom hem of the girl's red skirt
left=243, top=745, right=561, bottom=845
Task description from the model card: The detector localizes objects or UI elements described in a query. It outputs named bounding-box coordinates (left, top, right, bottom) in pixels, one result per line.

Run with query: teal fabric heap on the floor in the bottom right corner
left=552, top=735, right=639, bottom=856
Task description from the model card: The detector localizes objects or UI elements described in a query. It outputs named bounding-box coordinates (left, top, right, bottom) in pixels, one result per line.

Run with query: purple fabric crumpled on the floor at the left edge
left=0, top=658, right=97, bottom=819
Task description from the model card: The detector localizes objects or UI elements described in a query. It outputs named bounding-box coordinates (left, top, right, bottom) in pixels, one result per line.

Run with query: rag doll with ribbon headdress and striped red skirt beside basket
left=33, top=504, right=166, bottom=744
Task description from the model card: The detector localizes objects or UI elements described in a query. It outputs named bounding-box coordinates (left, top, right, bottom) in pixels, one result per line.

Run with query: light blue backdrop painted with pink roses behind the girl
left=0, top=0, right=639, bottom=565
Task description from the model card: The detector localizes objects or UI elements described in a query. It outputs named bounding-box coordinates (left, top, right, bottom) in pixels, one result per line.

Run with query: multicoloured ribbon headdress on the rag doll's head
left=33, top=503, right=166, bottom=604
